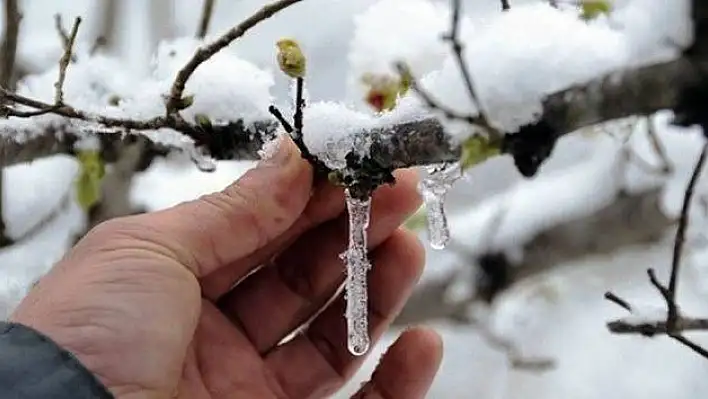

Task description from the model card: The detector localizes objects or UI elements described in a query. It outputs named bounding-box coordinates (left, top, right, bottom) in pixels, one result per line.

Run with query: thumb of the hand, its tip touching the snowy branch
left=108, top=136, right=312, bottom=277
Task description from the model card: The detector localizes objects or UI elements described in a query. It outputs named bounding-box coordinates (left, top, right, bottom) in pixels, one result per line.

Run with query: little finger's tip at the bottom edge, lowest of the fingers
left=352, top=328, right=443, bottom=399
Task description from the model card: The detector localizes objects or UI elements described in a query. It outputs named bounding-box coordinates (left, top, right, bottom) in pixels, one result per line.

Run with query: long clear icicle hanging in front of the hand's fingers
left=339, top=189, right=371, bottom=356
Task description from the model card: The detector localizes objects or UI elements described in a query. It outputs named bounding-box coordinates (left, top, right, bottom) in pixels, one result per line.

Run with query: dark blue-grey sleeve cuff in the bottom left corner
left=0, top=321, right=114, bottom=399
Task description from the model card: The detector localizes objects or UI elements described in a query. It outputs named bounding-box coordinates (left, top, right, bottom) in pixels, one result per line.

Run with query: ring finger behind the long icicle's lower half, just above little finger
left=266, top=230, right=425, bottom=398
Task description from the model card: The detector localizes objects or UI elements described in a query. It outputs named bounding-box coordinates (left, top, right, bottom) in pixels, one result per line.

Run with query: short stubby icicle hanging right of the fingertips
left=418, top=163, right=462, bottom=249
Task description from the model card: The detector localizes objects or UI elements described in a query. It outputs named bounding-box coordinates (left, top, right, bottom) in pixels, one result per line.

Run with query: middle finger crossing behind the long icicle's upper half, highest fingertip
left=219, top=171, right=420, bottom=353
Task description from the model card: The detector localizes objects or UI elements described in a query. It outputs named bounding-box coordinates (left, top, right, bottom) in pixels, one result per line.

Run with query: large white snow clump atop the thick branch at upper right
left=421, top=3, right=629, bottom=138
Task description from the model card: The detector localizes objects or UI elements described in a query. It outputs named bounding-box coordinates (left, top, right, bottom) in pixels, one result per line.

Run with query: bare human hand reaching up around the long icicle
left=11, top=139, right=442, bottom=399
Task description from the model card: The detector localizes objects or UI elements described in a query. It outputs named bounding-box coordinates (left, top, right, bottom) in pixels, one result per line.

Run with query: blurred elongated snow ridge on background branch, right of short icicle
left=450, top=138, right=624, bottom=254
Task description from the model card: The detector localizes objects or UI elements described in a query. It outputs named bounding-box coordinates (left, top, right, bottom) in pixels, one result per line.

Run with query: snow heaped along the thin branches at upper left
left=0, top=39, right=273, bottom=152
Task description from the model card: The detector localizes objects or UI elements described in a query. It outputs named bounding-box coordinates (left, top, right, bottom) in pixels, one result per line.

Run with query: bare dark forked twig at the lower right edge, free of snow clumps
left=605, top=143, right=708, bottom=358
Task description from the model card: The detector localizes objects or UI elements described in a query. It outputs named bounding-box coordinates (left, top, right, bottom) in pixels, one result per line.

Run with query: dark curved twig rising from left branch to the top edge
left=165, top=0, right=302, bottom=115
